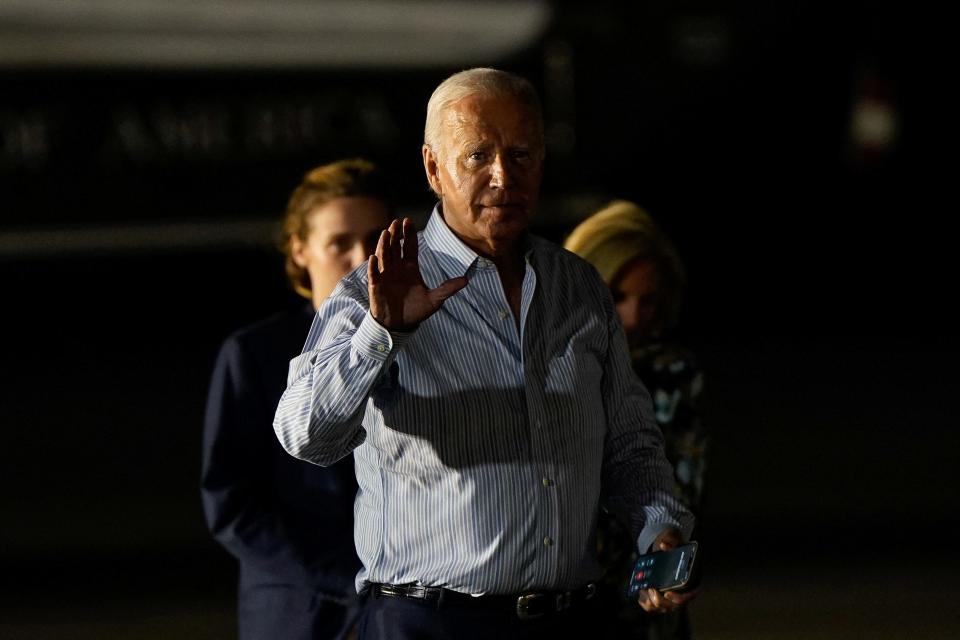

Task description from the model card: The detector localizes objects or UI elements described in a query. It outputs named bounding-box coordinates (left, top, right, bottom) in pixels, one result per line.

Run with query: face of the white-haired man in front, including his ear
left=423, top=95, right=543, bottom=255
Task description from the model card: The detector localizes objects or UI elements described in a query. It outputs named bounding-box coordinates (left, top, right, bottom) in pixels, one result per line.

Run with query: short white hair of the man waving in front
left=423, top=67, right=543, bottom=155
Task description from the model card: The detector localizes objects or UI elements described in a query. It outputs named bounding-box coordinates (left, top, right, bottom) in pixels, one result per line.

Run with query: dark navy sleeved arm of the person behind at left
left=200, top=338, right=305, bottom=577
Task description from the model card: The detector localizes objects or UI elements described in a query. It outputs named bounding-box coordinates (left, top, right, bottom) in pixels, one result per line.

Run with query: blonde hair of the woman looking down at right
left=563, top=200, right=686, bottom=327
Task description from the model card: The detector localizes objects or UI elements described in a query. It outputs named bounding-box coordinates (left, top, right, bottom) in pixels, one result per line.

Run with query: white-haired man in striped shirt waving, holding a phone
left=274, top=69, right=692, bottom=639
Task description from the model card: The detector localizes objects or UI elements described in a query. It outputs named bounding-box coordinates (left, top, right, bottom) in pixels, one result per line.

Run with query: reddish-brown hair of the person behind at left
left=280, top=158, right=391, bottom=299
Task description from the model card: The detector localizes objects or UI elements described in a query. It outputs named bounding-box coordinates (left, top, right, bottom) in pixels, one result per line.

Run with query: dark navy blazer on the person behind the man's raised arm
left=201, top=305, right=360, bottom=603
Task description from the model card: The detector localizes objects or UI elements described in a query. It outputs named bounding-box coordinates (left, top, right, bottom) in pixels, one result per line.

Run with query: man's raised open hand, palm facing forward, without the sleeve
left=367, top=218, right=468, bottom=331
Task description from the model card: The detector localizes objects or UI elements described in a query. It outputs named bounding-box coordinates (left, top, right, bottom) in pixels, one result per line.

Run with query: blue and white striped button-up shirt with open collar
left=274, top=209, right=692, bottom=594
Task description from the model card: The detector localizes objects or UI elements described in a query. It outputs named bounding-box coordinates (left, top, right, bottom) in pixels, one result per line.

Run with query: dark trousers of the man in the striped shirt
left=359, top=594, right=607, bottom=640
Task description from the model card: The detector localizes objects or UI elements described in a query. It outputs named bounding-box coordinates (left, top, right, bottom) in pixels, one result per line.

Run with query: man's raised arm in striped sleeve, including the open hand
left=273, top=219, right=467, bottom=465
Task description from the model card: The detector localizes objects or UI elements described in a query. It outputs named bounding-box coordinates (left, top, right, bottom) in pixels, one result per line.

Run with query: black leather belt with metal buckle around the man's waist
left=370, top=582, right=597, bottom=620
